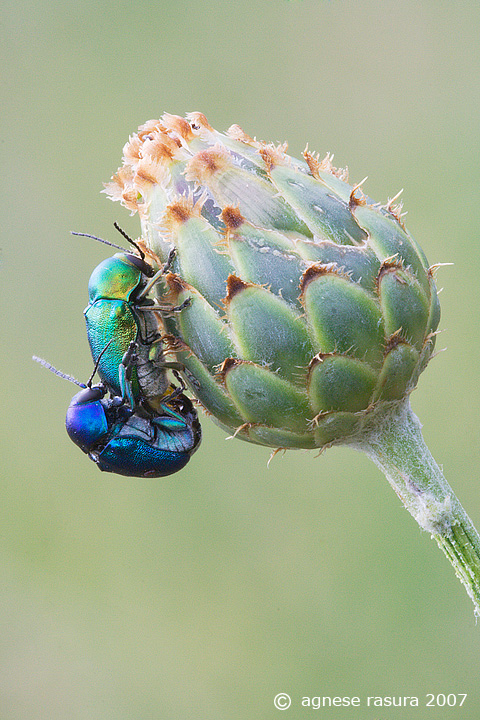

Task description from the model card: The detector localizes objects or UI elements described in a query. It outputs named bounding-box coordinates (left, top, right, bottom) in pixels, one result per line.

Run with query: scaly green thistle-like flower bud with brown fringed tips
left=107, top=113, right=439, bottom=448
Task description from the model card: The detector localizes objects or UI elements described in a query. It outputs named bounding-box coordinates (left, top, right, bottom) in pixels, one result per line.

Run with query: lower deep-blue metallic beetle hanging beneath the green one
left=33, top=348, right=201, bottom=478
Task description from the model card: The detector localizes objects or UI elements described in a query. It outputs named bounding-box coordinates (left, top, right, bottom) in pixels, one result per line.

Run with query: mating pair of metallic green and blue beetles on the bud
left=34, top=226, right=201, bottom=477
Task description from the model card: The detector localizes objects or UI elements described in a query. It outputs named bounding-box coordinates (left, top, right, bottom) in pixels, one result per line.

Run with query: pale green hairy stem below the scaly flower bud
left=351, top=399, right=480, bottom=616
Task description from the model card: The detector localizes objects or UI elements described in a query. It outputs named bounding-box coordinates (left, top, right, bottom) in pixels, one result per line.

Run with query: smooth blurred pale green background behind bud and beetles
left=0, top=0, right=480, bottom=720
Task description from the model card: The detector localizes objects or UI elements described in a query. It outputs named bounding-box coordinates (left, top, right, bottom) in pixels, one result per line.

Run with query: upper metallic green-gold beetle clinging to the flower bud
left=74, top=223, right=190, bottom=405
